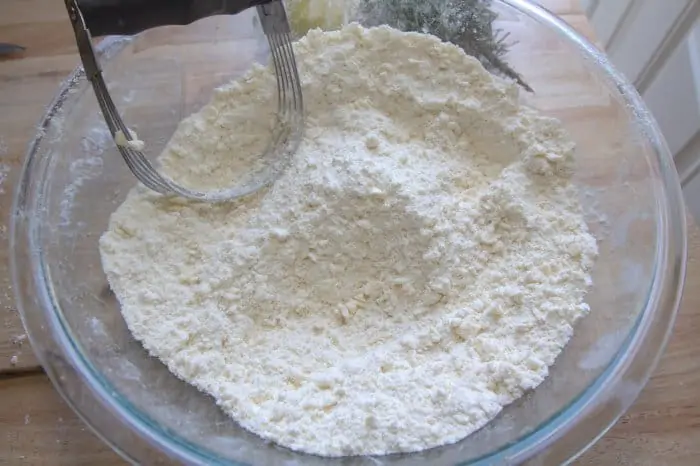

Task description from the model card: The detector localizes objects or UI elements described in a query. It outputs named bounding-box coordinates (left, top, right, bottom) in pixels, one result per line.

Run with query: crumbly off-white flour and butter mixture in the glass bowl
left=100, top=25, right=597, bottom=456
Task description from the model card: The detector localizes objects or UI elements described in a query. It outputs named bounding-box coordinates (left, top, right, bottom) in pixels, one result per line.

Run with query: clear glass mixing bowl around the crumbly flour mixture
left=11, top=0, right=685, bottom=465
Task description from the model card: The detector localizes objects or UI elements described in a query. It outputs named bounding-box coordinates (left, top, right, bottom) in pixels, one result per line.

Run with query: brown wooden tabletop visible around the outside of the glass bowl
left=0, top=0, right=700, bottom=466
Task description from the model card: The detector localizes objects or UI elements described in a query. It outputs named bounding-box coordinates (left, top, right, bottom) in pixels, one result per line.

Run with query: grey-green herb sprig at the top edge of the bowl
left=358, top=0, right=532, bottom=92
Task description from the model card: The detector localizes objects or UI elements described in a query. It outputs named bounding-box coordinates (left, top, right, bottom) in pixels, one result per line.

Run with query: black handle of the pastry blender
left=78, top=0, right=272, bottom=36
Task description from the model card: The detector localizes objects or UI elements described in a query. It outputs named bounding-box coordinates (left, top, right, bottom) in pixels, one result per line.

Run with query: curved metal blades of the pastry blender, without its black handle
left=65, top=0, right=303, bottom=202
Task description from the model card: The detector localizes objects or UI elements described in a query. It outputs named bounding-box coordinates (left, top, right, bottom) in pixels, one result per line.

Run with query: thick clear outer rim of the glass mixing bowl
left=9, top=0, right=687, bottom=465
